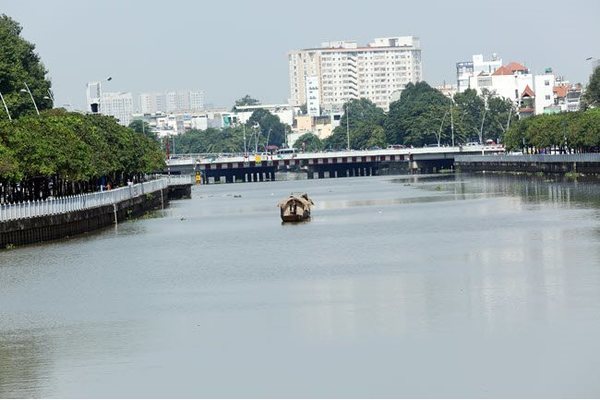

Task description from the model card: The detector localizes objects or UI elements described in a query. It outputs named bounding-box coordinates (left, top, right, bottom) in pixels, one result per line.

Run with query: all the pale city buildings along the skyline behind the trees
left=87, top=36, right=598, bottom=148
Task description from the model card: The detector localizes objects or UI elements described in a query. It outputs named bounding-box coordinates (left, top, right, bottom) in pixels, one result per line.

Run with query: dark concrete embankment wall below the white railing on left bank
left=0, top=188, right=169, bottom=250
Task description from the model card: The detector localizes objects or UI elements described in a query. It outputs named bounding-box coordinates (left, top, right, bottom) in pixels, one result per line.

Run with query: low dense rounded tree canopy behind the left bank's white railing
left=0, top=110, right=164, bottom=181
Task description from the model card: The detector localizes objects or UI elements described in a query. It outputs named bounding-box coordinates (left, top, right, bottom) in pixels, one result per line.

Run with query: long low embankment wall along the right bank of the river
left=454, top=154, right=600, bottom=174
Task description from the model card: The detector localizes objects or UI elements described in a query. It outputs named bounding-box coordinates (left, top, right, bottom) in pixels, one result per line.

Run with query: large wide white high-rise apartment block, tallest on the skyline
left=288, top=36, right=423, bottom=114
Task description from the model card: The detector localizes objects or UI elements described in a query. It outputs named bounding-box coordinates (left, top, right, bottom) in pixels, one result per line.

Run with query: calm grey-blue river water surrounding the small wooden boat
left=0, top=175, right=600, bottom=398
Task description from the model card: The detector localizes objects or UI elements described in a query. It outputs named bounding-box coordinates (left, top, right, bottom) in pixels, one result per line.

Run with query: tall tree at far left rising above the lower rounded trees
left=0, top=14, right=52, bottom=120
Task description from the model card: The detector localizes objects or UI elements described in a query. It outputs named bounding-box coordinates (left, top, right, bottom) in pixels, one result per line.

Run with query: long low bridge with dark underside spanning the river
left=166, top=145, right=504, bottom=183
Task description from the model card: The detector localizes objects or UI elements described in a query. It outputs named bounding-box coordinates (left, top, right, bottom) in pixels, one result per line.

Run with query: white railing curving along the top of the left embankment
left=0, top=178, right=169, bottom=222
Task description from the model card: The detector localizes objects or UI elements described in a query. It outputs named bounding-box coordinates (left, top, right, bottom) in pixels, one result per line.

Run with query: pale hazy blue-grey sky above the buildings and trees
left=0, top=0, right=600, bottom=108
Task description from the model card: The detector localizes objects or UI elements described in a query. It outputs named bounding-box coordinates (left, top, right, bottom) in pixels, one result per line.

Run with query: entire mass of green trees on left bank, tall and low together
left=0, top=15, right=164, bottom=203
